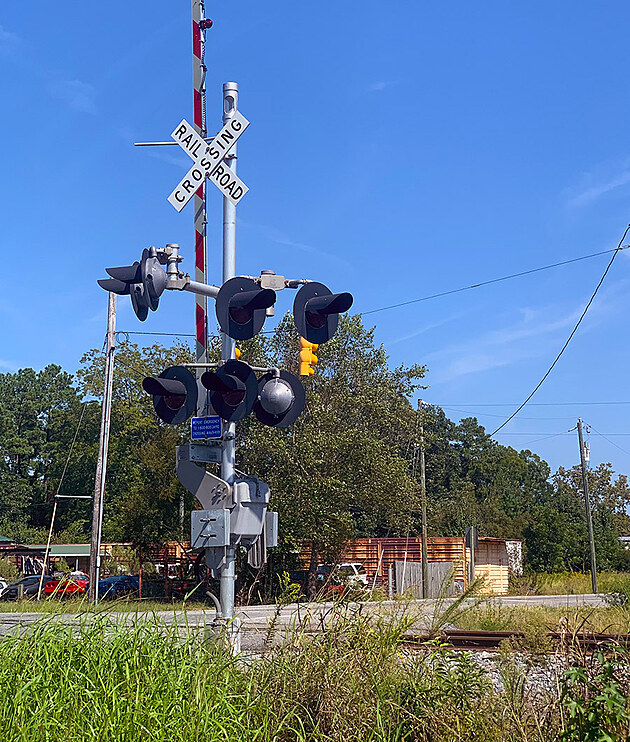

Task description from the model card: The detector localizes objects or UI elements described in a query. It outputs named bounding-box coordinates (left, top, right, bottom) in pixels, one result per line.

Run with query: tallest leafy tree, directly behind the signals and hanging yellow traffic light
left=239, top=316, right=424, bottom=591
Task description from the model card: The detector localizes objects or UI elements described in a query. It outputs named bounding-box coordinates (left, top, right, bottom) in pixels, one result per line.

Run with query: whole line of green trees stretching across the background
left=0, top=316, right=630, bottom=571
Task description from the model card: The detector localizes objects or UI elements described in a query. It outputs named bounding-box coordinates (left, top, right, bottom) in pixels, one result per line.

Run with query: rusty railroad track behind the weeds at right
left=404, top=629, right=630, bottom=652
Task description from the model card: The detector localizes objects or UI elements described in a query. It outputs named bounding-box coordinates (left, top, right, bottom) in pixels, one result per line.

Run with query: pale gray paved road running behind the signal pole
left=0, top=594, right=606, bottom=644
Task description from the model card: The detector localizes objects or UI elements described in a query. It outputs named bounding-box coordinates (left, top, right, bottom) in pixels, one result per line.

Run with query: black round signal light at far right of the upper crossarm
left=293, top=281, right=353, bottom=344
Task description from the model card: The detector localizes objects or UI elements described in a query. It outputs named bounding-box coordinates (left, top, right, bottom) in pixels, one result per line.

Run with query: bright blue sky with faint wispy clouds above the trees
left=0, top=0, right=630, bottom=472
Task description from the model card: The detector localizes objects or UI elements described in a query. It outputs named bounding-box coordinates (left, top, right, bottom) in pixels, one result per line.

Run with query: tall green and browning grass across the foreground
left=0, top=612, right=544, bottom=742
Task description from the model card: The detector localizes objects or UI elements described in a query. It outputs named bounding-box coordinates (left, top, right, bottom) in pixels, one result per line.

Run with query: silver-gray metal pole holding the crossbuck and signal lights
left=220, top=82, right=239, bottom=648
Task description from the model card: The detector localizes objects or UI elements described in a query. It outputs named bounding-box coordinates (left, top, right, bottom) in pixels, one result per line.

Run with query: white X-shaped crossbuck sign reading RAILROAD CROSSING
left=168, top=111, right=249, bottom=211
